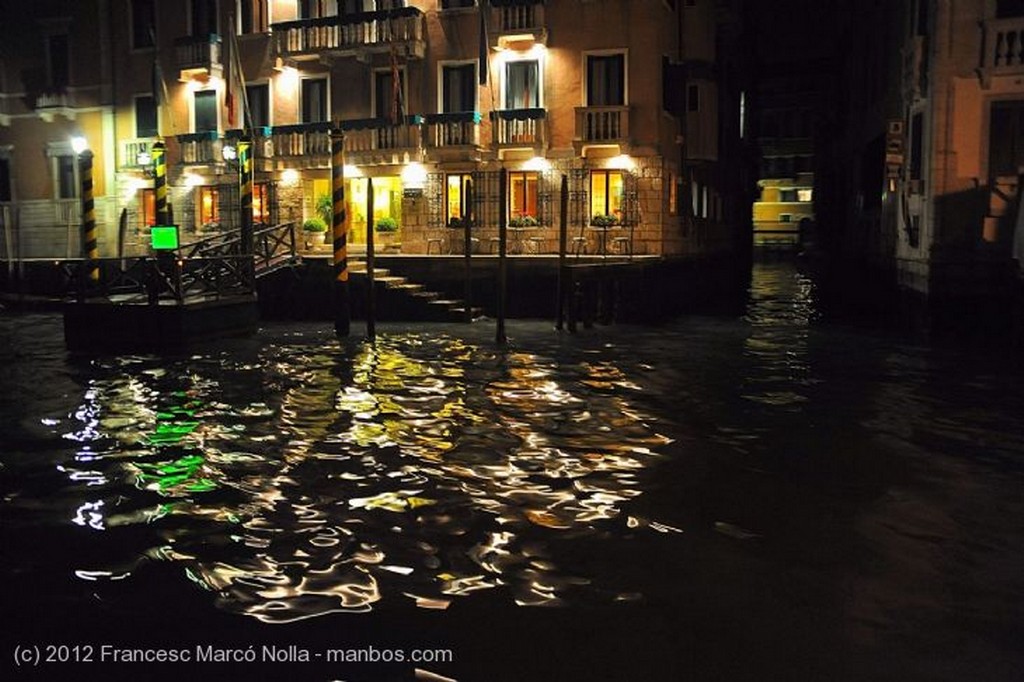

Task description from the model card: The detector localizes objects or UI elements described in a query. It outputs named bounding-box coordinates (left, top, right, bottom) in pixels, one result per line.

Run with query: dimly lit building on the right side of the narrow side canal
left=822, top=0, right=1024, bottom=300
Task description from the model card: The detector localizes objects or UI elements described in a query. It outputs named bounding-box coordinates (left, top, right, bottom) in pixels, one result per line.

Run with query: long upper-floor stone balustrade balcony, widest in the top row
left=271, top=7, right=426, bottom=60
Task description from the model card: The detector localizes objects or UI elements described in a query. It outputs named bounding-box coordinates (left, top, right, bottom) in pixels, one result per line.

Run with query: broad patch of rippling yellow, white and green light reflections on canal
left=59, top=333, right=671, bottom=623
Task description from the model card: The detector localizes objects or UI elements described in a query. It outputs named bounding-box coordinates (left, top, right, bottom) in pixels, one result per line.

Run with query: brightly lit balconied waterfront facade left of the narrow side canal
left=0, top=0, right=742, bottom=258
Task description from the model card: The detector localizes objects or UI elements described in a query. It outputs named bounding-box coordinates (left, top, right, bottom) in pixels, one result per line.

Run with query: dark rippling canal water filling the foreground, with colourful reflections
left=0, top=262, right=1024, bottom=682
